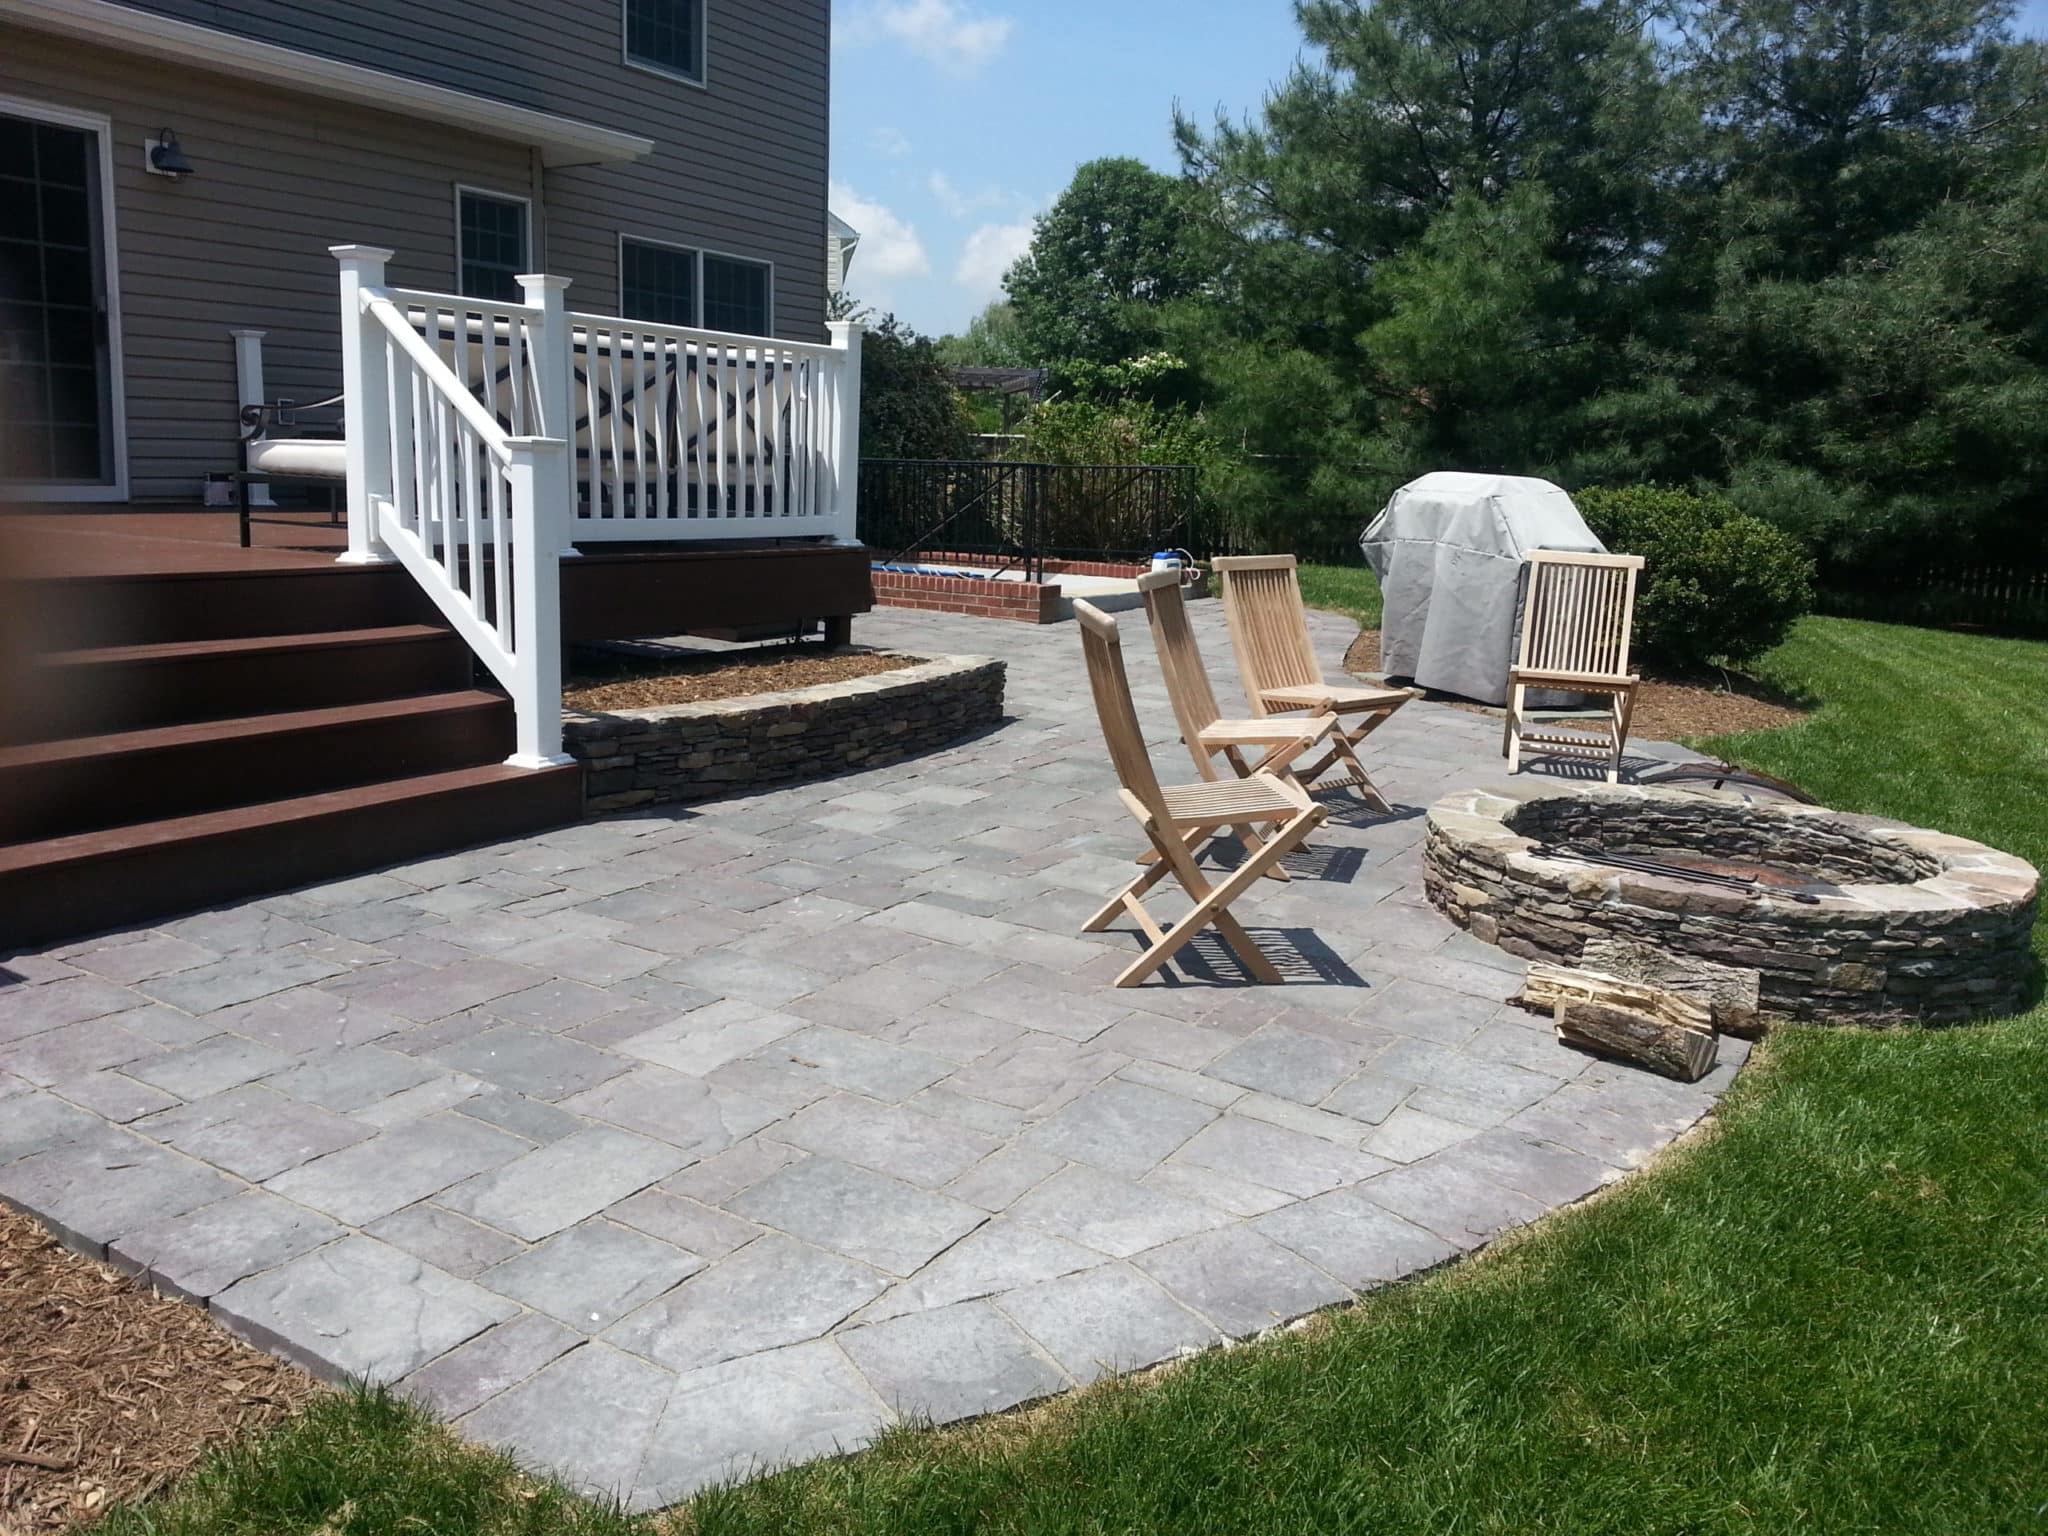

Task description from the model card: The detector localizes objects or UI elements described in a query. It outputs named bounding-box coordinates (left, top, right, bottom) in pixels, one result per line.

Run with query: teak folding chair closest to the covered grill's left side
left=1212, top=555, right=1415, bottom=813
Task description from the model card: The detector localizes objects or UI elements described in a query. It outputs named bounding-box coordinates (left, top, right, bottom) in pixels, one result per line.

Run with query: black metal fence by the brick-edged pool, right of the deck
left=858, top=459, right=1200, bottom=575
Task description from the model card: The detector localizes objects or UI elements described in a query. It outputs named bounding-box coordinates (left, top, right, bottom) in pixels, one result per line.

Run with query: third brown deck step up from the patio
left=18, top=625, right=473, bottom=741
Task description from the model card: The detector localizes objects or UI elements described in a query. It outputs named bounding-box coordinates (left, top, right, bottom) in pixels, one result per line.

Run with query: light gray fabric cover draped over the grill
left=1358, top=473, right=1604, bottom=709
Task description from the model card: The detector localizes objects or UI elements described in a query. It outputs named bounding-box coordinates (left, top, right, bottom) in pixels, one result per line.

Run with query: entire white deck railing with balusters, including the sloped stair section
left=334, top=246, right=860, bottom=768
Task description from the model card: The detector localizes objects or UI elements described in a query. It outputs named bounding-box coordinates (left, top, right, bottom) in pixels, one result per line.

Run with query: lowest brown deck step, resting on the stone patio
left=0, top=764, right=584, bottom=950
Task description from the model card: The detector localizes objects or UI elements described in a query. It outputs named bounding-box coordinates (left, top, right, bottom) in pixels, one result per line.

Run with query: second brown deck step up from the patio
left=0, top=688, right=514, bottom=844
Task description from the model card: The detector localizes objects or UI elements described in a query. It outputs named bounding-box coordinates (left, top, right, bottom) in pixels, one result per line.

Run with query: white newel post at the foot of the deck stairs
left=506, top=434, right=569, bottom=768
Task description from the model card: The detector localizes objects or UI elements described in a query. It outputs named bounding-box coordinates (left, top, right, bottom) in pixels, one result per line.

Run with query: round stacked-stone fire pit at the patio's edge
left=1423, top=784, right=2040, bottom=1024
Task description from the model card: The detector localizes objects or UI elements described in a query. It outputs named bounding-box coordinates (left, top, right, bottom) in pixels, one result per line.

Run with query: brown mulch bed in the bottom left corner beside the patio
left=0, top=1212, right=319, bottom=1536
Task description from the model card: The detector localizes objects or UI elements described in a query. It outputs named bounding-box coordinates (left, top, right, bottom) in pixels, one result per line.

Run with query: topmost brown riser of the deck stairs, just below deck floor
left=8, top=565, right=436, bottom=651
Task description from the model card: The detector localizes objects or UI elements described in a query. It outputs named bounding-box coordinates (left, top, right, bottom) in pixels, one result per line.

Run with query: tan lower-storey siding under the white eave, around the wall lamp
left=0, top=27, right=532, bottom=500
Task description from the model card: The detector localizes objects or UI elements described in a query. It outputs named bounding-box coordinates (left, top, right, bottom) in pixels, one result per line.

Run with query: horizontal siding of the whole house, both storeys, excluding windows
left=0, top=0, right=829, bottom=500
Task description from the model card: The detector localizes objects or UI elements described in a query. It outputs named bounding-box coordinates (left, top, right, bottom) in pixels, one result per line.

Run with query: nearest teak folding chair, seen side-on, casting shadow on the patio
left=1073, top=602, right=1329, bottom=987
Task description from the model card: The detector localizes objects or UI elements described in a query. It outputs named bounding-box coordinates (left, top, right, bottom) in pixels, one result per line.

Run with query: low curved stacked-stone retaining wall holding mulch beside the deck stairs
left=561, top=655, right=1006, bottom=811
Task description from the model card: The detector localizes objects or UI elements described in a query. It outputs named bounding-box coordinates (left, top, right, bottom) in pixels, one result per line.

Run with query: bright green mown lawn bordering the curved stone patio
left=109, top=618, right=2048, bottom=1536
